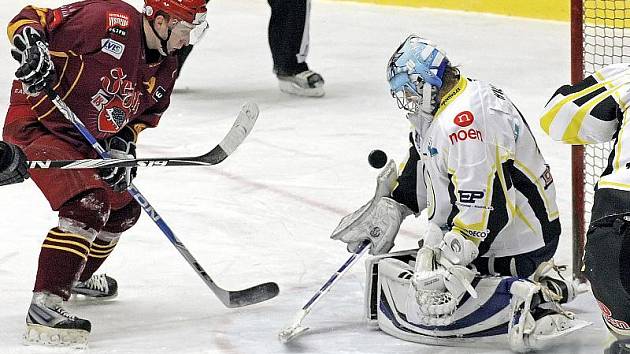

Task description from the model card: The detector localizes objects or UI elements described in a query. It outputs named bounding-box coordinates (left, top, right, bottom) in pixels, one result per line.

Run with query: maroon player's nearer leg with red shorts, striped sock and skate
left=24, top=135, right=110, bottom=346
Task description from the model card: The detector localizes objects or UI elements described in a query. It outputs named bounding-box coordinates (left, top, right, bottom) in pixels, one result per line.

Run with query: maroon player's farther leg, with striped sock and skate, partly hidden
left=72, top=198, right=141, bottom=300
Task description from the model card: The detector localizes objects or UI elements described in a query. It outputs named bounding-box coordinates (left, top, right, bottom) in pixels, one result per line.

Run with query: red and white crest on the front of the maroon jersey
left=91, top=68, right=142, bottom=133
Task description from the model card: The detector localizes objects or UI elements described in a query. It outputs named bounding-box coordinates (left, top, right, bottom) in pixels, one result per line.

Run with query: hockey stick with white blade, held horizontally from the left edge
left=27, top=102, right=260, bottom=169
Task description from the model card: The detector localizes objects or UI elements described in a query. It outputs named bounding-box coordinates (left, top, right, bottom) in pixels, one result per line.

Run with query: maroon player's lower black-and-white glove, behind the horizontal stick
left=99, top=126, right=138, bottom=192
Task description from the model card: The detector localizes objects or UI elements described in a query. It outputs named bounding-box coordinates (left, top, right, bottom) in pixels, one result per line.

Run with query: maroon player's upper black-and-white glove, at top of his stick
left=11, top=26, right=55, bottom=95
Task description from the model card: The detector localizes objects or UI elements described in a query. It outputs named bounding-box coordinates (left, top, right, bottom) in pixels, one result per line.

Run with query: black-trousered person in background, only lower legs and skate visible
left=178, top=0, right=325, bottom=97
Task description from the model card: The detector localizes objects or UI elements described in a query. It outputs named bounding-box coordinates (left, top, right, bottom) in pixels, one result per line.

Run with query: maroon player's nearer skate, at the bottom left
left=24, top=292, right=92, bottom=348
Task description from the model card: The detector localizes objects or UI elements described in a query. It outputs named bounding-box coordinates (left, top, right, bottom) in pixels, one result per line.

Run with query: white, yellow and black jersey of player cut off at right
left=540, top=64, right=630, bottom=221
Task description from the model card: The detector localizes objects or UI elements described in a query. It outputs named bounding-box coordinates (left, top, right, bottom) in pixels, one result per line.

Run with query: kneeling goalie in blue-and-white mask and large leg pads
left=332, top=35, right=587, bottom=352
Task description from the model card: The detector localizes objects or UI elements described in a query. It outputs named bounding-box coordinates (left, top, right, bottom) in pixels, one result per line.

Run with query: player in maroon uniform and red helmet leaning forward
left=3, top=0, right=207, bottom=346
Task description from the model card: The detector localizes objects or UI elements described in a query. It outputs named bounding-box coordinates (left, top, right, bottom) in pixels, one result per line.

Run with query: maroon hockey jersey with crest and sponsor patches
left=4, top=0, right=177, bottom=152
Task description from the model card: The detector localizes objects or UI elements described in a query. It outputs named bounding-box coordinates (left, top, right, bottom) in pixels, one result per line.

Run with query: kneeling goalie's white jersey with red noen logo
left=392, top=76, right=560, bottom=257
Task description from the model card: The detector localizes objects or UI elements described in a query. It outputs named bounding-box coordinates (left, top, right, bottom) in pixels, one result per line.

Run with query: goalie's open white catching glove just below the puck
left=330, top=160, right=411, bottom=255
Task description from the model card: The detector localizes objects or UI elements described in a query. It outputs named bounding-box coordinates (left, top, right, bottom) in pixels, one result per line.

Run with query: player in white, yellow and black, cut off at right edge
left=540, top=64, right=630, bottom=353
